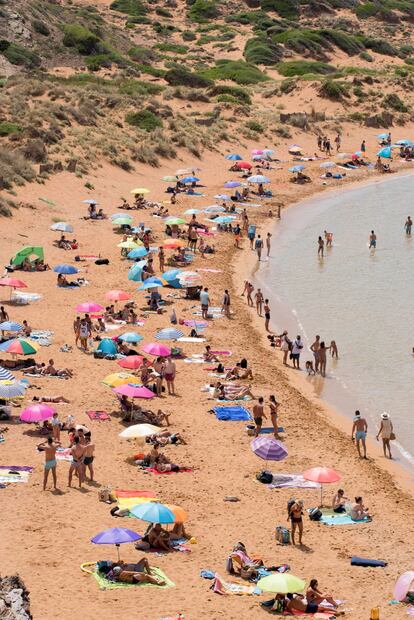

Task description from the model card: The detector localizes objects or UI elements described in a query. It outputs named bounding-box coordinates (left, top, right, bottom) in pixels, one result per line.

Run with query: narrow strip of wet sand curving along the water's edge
left=233, top=170, right=414, bottom=498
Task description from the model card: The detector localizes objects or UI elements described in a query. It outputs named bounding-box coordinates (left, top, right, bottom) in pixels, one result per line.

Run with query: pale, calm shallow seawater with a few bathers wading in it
left=256, top=175, right=414, bottom=465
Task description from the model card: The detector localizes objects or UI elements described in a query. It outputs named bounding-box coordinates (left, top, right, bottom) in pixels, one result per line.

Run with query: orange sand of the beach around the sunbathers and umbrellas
left=0, top=137, right=414, bottom=620
